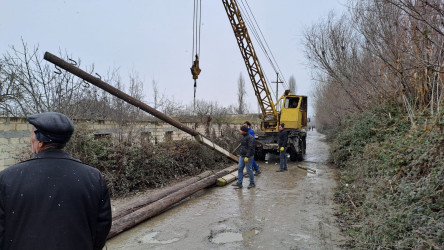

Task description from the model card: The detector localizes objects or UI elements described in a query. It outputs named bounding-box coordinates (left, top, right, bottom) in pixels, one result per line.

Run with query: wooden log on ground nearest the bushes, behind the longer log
left=113, top=171, right=214, bottom=221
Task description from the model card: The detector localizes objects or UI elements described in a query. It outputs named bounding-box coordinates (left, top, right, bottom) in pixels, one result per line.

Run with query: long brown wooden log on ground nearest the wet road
left=107, top=166, right=237, bottom=239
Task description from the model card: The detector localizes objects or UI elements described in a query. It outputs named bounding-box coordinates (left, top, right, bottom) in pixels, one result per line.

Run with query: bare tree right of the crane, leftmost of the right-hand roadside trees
left=305, top=14, right=367, bottom=115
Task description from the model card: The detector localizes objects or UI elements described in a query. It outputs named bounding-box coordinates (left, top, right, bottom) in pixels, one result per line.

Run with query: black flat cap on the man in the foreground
left=28, top=112, right=74, bottom=143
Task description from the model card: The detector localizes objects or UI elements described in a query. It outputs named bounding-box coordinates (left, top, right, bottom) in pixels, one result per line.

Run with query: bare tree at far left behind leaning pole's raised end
left=0, top=41, right=158, bottom=121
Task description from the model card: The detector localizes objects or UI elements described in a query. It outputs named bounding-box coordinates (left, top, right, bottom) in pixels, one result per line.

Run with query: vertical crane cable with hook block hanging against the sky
left=190, top=0, right=202, bottom=111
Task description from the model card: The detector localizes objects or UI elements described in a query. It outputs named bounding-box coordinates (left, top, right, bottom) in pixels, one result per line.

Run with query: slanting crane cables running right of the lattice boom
left=240, top=0, right=288, bottom=89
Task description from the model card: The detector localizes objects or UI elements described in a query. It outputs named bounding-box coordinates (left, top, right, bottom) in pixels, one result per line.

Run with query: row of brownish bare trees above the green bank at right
left=305, top=0, right=444, bottom=131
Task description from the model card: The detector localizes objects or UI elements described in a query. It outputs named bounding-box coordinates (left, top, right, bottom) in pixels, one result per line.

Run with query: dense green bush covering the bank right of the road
left=331, top=103, right=444, bottom=249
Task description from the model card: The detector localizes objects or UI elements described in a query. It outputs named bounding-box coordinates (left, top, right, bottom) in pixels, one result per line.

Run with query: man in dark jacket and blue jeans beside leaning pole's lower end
left=233, top=126, right=256, bottom=189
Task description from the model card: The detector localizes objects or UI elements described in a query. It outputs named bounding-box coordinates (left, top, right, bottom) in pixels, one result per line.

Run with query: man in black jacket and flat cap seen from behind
left=0, top=112, right=111, bottom=250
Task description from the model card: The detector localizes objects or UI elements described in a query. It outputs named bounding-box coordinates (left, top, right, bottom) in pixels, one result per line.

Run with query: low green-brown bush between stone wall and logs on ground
left=67, top=124, right=232, bottom=197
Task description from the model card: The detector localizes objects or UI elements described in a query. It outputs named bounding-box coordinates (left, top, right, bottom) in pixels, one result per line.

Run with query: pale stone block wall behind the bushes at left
left=0, top=117, right=240, bottom=170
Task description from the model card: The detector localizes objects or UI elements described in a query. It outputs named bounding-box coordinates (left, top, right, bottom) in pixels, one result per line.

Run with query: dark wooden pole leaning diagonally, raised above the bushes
left=43, top=52, right=239, bottom=162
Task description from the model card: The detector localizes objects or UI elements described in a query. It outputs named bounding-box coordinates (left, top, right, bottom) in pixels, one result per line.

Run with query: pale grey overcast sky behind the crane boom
left=0, top=0, right=346, bottom=113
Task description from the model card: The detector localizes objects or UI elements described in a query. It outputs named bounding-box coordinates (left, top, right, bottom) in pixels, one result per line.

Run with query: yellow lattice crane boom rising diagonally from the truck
left=222, top=0, right=278, bottom=131
